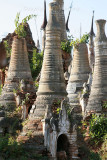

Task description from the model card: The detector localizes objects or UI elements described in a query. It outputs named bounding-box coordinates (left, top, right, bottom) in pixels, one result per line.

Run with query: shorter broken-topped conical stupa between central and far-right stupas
left=67, top=43, right=90, bottom=101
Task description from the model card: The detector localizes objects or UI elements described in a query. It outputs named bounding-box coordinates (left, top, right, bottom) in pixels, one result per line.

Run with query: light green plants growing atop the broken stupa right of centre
left=70, top=34, right=89, bottom=48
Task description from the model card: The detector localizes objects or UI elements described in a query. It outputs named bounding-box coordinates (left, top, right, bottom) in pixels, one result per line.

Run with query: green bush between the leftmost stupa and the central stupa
left=30, top=49, right=43, bottom=80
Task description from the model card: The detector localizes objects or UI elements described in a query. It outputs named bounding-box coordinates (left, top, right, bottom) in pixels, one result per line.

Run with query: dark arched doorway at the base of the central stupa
left=57, top=134, right=69, bottom=160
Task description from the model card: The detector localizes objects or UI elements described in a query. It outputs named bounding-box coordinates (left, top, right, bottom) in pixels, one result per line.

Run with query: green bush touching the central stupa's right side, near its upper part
left=61, top=36, right=73, bottom=53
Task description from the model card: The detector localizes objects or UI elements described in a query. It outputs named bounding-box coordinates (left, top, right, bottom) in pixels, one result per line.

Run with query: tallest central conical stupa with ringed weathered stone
left=31, top=2, right=67, bottom=118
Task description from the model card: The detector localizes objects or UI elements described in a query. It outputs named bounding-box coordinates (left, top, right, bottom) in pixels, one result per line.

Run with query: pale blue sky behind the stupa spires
left=0, top=0, right=107, bottom=46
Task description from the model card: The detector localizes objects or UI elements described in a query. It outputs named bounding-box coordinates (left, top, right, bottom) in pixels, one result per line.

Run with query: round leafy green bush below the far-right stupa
left=89, top=115, right=107, bottom=144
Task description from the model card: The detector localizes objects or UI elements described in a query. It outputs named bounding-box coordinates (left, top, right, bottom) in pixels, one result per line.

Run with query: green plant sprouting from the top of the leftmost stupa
left=14, top=13, right=36, bottom=38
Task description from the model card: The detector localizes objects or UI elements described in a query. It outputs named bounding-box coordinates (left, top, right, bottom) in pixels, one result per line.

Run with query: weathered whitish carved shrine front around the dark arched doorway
left=42, top=99, right=78, bottom=160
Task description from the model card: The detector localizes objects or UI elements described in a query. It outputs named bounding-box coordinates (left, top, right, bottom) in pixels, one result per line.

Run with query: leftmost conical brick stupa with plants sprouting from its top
left=0, top=37, right=34, bottom=106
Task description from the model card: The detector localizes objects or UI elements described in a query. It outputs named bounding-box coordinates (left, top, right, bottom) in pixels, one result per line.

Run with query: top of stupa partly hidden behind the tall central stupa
left=53, top=0, right=67, bottom=41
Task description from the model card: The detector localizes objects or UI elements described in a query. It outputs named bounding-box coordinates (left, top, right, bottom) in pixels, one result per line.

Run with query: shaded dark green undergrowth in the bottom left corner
left=0, top=132, right=48, bottom=160
